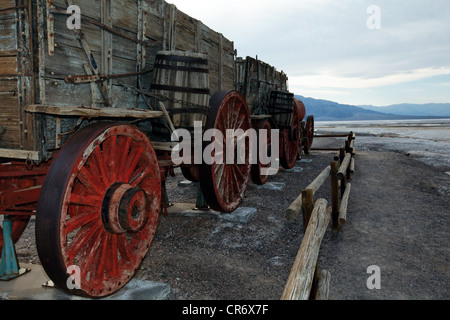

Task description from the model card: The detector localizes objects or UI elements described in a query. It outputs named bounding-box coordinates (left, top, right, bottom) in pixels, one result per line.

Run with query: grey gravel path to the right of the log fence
left=321, top=152, right=450, bottom=299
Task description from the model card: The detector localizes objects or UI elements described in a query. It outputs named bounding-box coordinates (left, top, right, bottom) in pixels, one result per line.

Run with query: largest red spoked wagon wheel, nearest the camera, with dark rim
left=36, top=123, right=161, bottom=297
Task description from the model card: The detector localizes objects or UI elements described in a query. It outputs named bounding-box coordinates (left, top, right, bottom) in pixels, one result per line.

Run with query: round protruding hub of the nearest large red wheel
left=102, top=182, right=148, bottom=234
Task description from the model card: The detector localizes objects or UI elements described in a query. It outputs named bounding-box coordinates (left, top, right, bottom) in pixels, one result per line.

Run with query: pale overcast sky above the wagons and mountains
left=167, top=0, right=450, bottom=106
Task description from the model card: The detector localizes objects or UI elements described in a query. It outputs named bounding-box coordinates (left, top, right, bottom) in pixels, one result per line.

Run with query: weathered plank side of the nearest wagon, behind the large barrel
left=0, top=0, right=239, bottom=161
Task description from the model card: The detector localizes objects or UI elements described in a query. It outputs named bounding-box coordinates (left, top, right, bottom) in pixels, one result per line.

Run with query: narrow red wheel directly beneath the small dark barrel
left=280, top=104, right=302, bottom=169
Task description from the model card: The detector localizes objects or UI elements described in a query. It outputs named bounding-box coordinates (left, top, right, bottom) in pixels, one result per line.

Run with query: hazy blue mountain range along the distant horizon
left=296, top=96, right=450, bottom=121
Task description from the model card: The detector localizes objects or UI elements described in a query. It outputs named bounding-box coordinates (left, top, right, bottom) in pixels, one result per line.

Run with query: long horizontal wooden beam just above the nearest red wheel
left=25, top=104, right=164, bottom=119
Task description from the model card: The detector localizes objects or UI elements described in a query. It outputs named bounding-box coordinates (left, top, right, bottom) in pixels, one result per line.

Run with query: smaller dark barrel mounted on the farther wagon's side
left=268, top=91, right=294, bottom=129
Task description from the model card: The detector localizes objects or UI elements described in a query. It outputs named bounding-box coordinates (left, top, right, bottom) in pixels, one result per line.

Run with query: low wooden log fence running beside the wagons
left=281, top=132, right=355, bottom=300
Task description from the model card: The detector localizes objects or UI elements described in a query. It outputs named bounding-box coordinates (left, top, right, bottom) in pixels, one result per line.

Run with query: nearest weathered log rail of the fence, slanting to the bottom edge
left=281, top=199, right=331, bottom=300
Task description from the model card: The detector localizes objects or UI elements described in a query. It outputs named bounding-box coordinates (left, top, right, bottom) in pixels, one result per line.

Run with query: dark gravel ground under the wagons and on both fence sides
left=11, top=122, right=450, bottom=300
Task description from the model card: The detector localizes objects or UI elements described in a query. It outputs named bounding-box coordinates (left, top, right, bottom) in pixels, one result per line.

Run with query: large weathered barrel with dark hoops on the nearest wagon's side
left=151, top=51, right=210, bottom=131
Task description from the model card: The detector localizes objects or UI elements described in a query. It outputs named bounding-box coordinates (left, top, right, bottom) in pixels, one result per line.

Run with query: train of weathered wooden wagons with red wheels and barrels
left=0, top=0, right=313, bottom=297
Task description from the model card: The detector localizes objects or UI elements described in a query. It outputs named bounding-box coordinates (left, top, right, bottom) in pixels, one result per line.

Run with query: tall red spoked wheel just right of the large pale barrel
left=200, top=91, right=252, bottom=212
